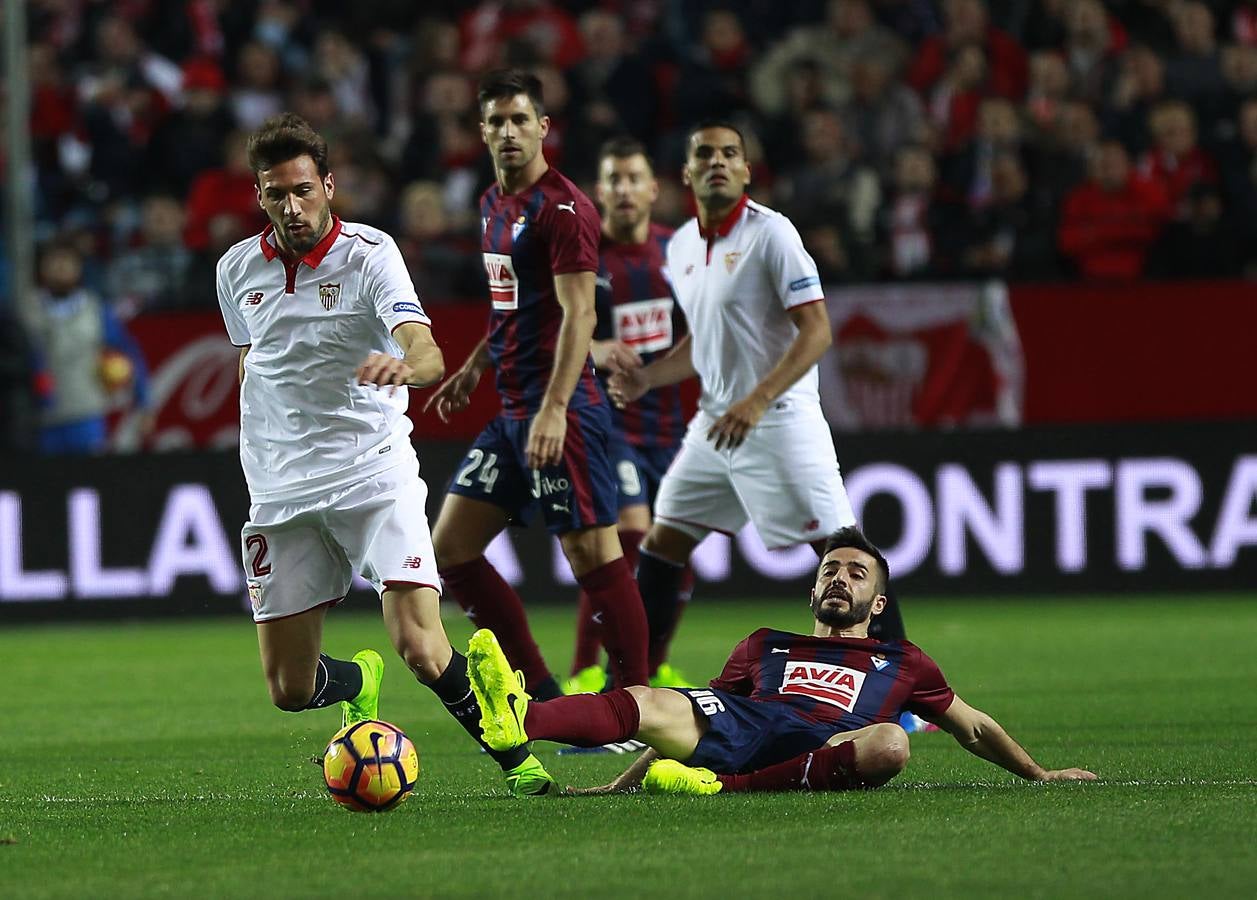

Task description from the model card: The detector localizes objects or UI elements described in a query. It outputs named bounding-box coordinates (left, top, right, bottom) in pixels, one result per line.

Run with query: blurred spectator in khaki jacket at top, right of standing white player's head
left=750, top=0, right=906, bottom=117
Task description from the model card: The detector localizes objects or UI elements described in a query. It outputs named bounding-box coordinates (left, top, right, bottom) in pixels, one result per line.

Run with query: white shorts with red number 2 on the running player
left=240, top=464, right=441, bottom=622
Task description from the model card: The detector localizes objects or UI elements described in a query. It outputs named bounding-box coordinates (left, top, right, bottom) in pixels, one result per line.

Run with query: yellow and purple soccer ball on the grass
left=323, top=722, right=419, bottom=812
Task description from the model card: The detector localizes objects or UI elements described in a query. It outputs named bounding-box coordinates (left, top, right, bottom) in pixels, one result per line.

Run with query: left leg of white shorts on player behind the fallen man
left=655, top=415, right=747, bottom=538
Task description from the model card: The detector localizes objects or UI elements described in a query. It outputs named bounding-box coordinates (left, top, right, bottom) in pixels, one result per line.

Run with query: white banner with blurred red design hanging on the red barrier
left=820, top=282, right=1024, bottom=431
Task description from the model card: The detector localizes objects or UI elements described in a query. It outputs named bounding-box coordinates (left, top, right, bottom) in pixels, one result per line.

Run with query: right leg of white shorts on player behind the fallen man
left=732, top=416, right=855, bottom=548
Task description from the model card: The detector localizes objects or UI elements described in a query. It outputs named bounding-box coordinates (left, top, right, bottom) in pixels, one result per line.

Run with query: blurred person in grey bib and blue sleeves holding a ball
left=33, top=243, right=148, bottom=454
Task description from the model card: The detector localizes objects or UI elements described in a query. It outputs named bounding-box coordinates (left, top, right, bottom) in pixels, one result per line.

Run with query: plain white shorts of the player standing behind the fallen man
left=655, top=410, right=856, bottom=549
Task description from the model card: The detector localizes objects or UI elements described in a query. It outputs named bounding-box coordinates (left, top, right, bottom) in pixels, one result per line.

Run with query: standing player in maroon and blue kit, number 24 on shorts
left=427, top=70, right=647, bottom=794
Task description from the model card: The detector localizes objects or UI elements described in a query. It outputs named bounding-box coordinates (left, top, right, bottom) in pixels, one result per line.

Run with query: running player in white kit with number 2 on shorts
left=217, top=113, right=548, bottom=789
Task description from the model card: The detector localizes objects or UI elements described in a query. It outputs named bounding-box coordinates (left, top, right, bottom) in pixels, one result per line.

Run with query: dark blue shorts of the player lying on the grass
left=672, top=688, right=836, bottom=776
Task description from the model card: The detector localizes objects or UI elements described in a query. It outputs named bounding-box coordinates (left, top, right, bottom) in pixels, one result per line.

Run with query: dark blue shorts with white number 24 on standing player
left=450, top=403, right=618, bottom=534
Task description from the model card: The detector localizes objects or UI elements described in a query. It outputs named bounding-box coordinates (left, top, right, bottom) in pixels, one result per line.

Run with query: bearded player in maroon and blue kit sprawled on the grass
left=468, top=525, right=1095, bottom=794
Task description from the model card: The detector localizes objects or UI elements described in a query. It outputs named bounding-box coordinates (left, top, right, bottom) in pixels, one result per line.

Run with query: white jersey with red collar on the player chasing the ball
left=217, top=219, right=430, bottom=504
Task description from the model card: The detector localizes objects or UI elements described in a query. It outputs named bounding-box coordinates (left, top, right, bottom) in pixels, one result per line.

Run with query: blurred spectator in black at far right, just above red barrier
left=1148, top=184, right=1243, bottom=278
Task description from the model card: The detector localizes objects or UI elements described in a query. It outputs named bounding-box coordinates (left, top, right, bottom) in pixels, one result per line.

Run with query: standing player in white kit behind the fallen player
left=611, top=121, right=903, bottom=650
